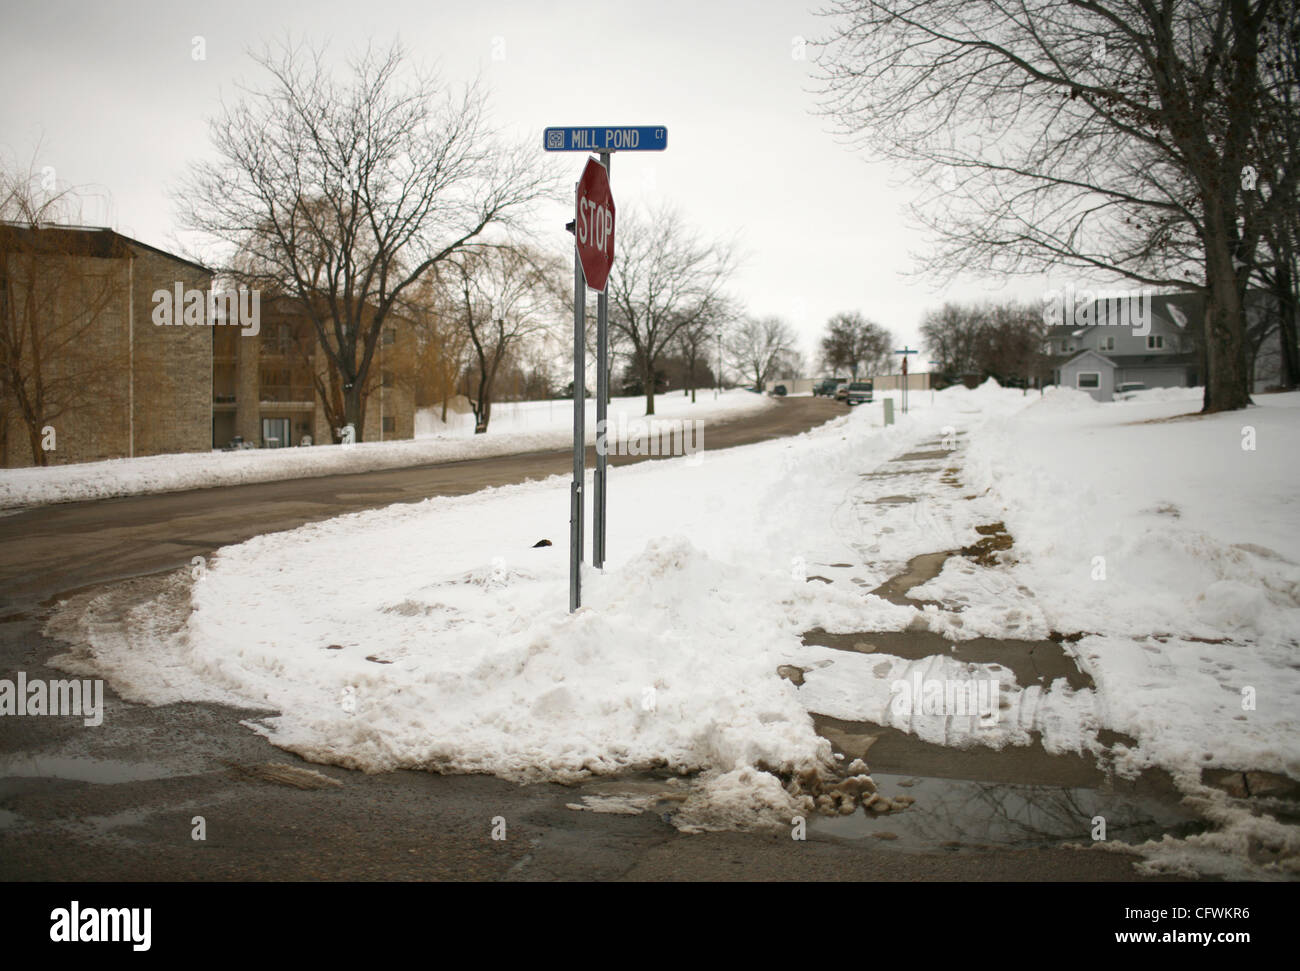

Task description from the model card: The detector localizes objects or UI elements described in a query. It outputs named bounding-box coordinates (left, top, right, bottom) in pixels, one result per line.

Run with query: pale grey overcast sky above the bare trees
left=0, top=0, right=1047, bottom=369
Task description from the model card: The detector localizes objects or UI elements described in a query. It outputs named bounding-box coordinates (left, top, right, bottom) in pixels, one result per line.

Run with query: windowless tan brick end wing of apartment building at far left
left=0, top=224, right=212, bottom=468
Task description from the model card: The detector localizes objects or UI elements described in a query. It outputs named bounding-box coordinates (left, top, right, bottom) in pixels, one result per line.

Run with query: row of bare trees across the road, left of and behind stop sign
left=10, top=34, right=816, bottom=459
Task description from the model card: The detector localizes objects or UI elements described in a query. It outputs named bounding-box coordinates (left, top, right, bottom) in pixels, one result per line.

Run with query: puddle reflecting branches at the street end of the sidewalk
left=809, top=772, right=1205, bottom=850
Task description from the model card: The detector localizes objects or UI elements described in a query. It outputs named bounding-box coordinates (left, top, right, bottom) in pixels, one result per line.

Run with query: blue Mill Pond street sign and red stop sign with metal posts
left=542, top=125, right=668, bottom=611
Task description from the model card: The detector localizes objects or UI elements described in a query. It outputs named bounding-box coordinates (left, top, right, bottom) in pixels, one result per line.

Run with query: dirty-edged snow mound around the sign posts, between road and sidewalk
left=50, top=393, right=1023, bottom=828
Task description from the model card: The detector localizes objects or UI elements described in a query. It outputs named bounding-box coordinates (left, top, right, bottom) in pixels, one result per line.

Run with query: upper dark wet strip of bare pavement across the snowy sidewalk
left=803, top=631, right=1096, bottom=692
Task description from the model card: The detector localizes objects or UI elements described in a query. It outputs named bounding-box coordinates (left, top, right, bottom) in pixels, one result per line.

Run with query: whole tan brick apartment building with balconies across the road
left=0, top=224, right=415, bottom=468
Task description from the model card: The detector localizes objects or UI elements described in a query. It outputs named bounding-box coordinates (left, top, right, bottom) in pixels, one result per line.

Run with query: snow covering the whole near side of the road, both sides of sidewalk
left=50, top=385, right=1300, bottom=866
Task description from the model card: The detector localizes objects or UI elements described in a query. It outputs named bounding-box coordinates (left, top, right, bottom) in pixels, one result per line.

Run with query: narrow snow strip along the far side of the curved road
left=0, top=390, right=775, bottom=508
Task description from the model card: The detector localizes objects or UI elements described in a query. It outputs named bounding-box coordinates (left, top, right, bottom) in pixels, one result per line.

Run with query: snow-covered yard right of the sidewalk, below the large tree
left=966, top=394, right=1300, bottom=785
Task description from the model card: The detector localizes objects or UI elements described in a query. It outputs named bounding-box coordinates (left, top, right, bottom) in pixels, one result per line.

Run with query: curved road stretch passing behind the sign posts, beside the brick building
left=0, top=398, right=848, bottom=614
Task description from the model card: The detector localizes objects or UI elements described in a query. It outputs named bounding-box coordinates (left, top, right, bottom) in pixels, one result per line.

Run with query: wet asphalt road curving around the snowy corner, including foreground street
left=0, top=399, right=1175, bottom=881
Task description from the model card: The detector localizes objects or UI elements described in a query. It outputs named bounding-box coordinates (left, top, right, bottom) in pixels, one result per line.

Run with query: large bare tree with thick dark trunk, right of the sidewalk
left=822, top=0, right=1294, bottom=412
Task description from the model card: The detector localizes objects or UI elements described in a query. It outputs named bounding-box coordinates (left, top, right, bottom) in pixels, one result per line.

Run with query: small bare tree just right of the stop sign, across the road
left=606, top=208, right=735, bottom=415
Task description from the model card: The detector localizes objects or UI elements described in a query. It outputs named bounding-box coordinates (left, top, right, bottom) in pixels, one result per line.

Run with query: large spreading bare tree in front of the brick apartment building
left=178, top=43, right=553, bottom=439
